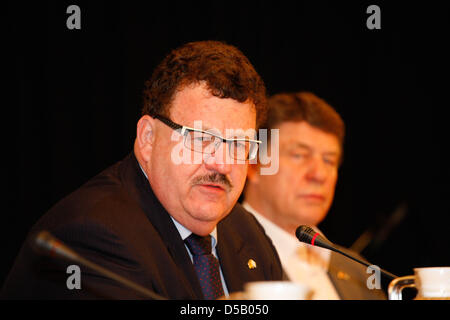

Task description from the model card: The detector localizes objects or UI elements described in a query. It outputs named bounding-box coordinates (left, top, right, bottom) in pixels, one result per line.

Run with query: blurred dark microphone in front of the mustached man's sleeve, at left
left=33, top=231, right=167, bottom=300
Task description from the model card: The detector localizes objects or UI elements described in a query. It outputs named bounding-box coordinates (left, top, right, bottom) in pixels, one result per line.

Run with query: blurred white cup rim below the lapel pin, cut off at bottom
left=244, top=281, right=311, bottom=300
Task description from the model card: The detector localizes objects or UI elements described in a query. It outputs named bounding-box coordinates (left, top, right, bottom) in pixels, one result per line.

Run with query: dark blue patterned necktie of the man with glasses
left=184, top=233, right=224, bottom=300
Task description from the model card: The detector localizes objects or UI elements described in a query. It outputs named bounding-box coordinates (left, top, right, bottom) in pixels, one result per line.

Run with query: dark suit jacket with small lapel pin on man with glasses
left=2, top=153, right=282, bottom=299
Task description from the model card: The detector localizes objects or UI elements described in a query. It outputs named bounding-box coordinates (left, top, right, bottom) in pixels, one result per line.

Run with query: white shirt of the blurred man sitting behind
left=243, top=202, right=339, bottom=300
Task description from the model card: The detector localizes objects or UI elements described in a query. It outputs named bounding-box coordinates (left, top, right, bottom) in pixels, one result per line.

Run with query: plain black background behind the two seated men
left=0, top=0, right=450, bottom=285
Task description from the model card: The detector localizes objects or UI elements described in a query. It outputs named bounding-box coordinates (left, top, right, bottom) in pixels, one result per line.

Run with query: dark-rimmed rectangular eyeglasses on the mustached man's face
left=152, top=114, right=262, bottom=161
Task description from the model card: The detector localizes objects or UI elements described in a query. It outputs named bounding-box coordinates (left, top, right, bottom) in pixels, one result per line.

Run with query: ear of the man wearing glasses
left=135, top=115, right=156, bottom=162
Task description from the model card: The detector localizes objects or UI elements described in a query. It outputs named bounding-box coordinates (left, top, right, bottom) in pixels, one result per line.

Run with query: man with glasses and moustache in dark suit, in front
left=3, top=41, right=282, bottom=299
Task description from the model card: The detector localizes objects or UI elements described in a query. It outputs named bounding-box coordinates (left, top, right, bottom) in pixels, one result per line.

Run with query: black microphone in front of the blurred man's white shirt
left=295, top=226, right=398, bottom=279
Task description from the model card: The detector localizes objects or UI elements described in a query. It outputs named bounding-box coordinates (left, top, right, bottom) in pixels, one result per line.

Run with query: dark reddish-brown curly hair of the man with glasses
left=142, top=41, right=267, bottom=127
